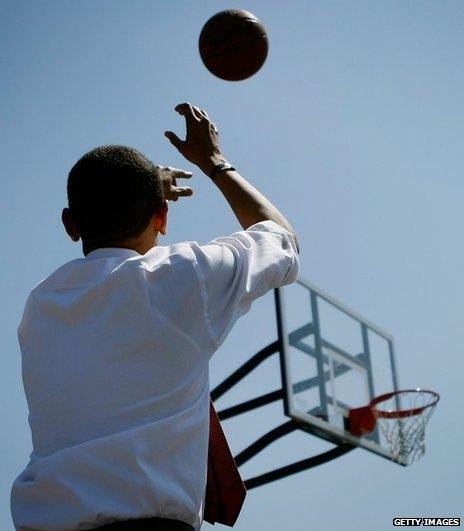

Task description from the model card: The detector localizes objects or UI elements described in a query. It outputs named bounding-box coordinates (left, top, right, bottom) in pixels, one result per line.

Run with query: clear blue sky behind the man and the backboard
left=0, top=0, right=464, bottom=531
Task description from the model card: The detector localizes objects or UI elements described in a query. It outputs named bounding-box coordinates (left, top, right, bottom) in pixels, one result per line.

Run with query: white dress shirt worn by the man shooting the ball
left=11, top=221, right=299, bottom=531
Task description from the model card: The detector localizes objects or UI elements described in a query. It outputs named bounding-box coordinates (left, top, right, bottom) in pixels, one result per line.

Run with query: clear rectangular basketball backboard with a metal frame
left=275, top=280, right=398, bottom=459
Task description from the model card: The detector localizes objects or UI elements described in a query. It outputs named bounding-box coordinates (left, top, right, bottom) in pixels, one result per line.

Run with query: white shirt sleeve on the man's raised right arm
left=193, top=220, right=299, bottom=348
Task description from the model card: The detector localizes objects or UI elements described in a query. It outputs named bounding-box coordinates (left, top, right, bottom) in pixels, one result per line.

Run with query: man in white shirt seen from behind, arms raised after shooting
left=11, top=103, right=299, bottom=531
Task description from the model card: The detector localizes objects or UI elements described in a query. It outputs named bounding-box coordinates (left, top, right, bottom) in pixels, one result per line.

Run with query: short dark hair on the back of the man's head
left=68, top=145, right=164, bottom=244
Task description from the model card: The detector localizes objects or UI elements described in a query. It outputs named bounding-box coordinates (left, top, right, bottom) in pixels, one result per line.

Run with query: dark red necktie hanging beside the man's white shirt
left=203, top=400, right=246, bottom=526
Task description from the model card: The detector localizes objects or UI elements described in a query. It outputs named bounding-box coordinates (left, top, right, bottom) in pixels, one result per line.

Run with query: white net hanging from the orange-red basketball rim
left=373, top=389, right=438, bottom=465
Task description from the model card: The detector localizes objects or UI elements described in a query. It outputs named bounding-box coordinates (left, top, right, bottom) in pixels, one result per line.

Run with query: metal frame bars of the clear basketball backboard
left=275, top=279, right=399, bottom=459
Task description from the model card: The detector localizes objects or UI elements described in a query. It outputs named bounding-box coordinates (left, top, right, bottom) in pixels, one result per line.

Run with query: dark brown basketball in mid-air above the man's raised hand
left=198, top=9, right=268, bottom=81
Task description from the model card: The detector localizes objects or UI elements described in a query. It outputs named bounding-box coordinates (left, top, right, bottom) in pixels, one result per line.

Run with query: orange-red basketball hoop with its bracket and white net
left=349, top=388, right=440, bottom=465
